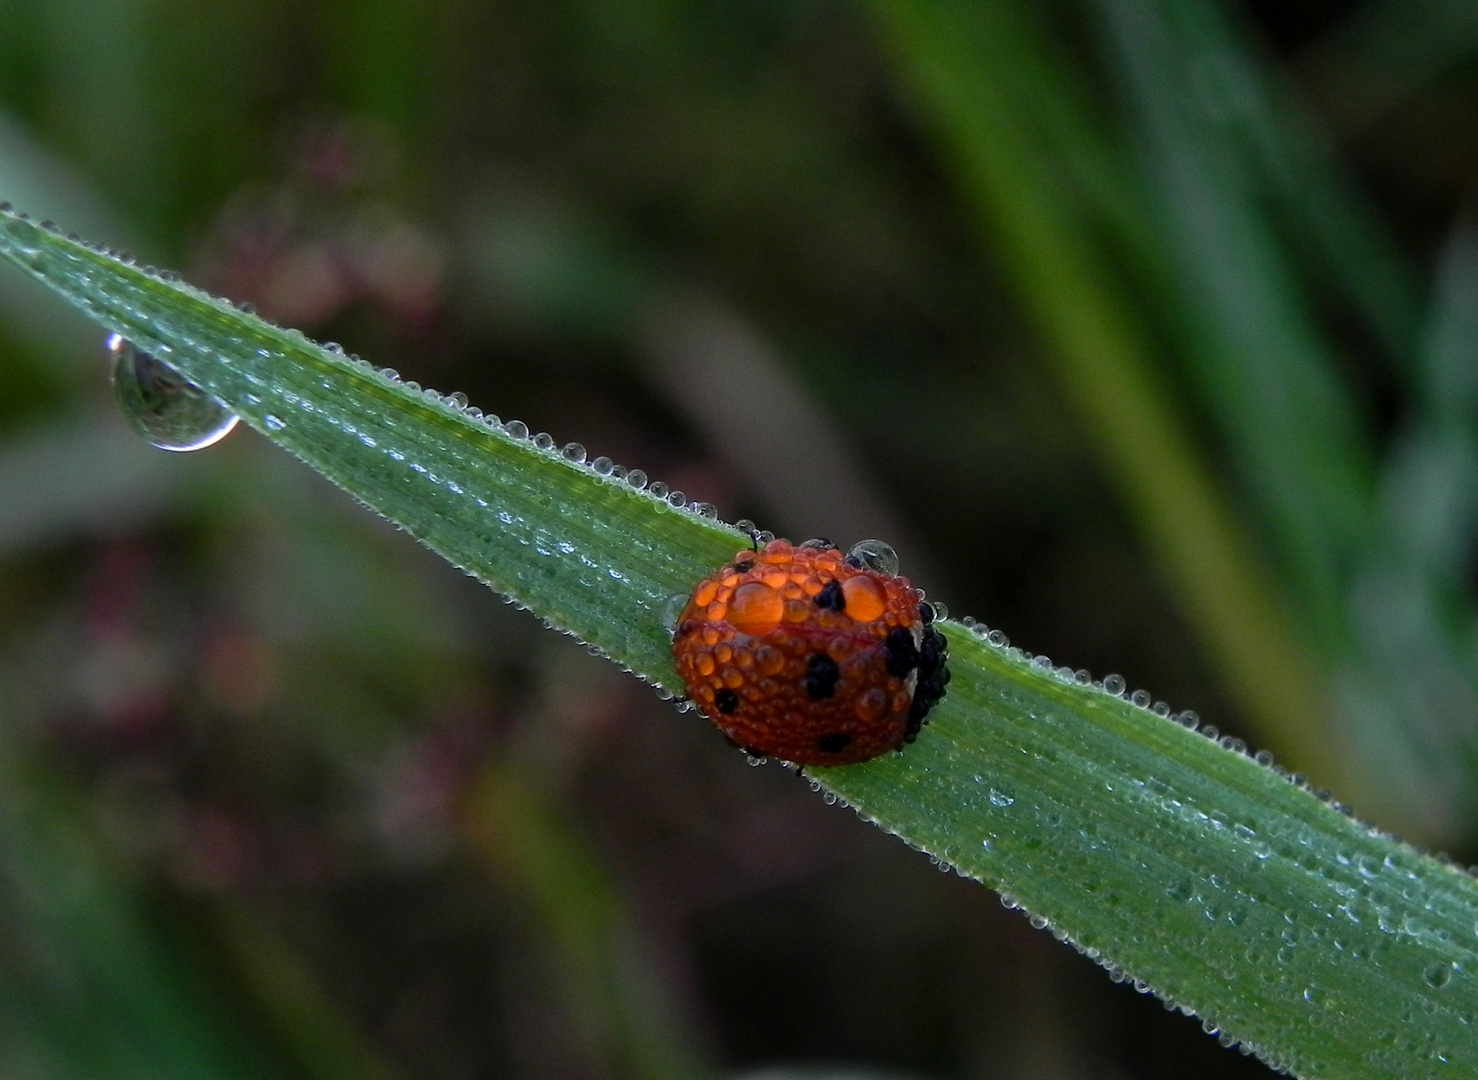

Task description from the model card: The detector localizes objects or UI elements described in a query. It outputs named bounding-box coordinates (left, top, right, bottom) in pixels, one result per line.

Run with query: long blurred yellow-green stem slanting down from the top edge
left=873, top=0, right=1346, bottom=786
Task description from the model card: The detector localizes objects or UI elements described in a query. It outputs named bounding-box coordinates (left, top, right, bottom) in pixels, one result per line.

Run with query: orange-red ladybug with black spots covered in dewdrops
left=672, top=539, right=949, bottom=765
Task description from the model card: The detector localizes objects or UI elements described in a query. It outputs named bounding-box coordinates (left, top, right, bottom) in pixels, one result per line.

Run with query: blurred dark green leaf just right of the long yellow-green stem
left=1100, top=0, right=1370, bottom=655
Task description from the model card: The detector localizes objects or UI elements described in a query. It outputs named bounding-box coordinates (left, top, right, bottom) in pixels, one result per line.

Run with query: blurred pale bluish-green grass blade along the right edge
left=1345, top=225, right=1478, bottom=832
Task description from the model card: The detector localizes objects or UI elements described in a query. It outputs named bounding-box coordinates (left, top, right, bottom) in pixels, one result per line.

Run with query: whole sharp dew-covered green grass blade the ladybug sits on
left=0, top=206, right=1478, bottom=1080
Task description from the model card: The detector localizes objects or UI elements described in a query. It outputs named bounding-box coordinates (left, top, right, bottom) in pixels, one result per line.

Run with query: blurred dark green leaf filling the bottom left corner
left=0, top=729, right=294, bottom=1080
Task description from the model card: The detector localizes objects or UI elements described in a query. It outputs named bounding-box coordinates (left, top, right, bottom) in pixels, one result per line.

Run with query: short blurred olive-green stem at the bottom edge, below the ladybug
left=463, top=762, right=708, bottom=1080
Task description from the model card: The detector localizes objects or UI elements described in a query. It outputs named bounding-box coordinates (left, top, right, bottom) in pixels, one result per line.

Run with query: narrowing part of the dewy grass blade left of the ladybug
left=3, top=209, right=748, bottom=680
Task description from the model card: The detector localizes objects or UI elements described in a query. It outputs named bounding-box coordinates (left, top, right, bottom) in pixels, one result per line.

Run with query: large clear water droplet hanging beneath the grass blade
left=108, top=334, right=236, bottom=452
